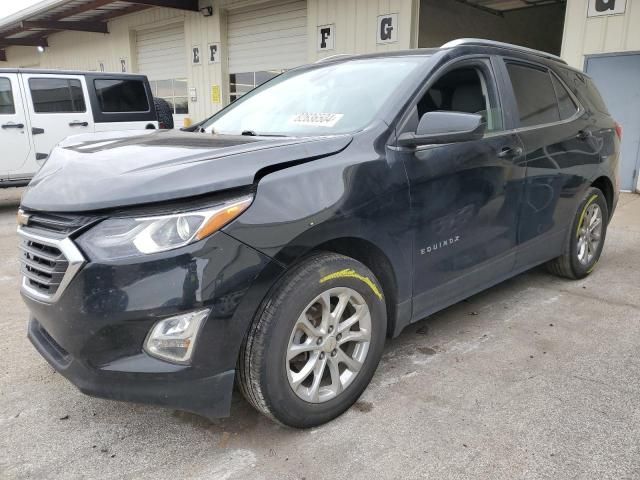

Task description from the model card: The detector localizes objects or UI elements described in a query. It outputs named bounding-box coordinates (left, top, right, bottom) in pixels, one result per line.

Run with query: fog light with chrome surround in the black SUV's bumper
left=144, top=309, right=210, bottom=364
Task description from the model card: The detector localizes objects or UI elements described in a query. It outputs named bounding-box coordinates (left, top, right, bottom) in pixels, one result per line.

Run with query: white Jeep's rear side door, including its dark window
left=22, top=74, right=94, bottom=165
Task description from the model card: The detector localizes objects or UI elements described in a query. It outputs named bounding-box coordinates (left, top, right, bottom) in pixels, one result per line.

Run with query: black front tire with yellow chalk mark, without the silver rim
left=238, top=253, right=387, bottom=428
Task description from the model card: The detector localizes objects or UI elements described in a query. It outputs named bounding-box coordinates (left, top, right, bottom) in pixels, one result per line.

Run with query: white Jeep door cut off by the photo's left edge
left=0, top=73, right=31, bottom=178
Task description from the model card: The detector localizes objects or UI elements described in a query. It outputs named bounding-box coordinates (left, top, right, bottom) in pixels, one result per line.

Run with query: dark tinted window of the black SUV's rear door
left=507, top=63, right=560, bottom=127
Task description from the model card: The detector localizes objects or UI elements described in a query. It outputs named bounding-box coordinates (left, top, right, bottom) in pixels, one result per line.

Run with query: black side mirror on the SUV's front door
left=398, top=112, right=487, bottom=147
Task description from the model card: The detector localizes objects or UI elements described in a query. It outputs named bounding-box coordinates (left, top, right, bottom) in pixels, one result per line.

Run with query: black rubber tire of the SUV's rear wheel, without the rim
left=546, top=188, right=609, bottom=280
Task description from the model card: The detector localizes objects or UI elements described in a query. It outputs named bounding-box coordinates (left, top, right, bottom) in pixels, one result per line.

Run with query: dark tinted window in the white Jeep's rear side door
left=29, top=78, right=86, bottom=113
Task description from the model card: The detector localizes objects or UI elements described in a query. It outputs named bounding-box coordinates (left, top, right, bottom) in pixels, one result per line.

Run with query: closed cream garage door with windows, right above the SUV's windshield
left=227, top=0, right=307, bottom=100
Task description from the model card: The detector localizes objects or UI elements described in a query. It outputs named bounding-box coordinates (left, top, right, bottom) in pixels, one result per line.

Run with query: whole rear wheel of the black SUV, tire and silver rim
left=547, top=188, right=609, bottom=279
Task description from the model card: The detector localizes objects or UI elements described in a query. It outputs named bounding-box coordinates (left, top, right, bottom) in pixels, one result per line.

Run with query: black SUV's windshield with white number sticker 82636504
left=202, top=57, right=424, bottom=136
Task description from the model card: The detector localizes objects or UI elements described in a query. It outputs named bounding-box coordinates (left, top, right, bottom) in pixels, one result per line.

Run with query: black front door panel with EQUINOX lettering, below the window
left=405, top=134, right=524, bottom=318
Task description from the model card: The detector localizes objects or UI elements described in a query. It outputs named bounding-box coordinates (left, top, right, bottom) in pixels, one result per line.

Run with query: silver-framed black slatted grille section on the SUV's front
left=20, top=238, right=69, bottom=296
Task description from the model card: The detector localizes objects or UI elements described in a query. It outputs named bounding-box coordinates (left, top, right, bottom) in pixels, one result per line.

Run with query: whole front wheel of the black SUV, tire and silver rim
left=238, top=253, right=387, bottom=428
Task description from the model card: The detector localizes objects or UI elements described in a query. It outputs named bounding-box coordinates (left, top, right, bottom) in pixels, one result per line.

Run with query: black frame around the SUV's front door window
left=393, top=54, right=508, bottom=142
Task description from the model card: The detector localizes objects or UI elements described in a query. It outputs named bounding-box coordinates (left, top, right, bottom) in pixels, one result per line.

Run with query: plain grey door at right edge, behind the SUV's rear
left=586, top=54, right=640, bottom=191
